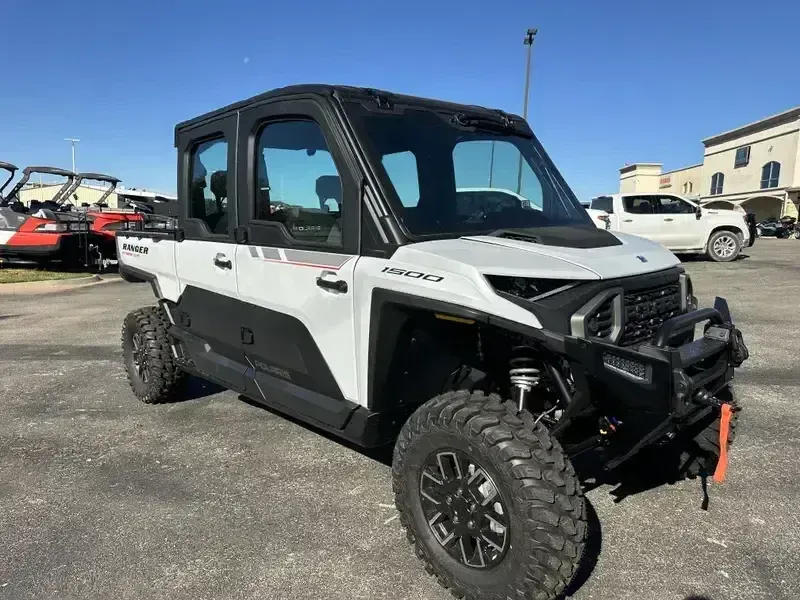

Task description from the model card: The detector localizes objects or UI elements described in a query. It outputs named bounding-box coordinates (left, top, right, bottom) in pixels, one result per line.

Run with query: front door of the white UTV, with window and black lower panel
left=236, top=99, right=360, bottom=428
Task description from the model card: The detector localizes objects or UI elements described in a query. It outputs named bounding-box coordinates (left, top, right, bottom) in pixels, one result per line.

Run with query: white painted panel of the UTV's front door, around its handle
left=236, top=245, right=360, bottom=403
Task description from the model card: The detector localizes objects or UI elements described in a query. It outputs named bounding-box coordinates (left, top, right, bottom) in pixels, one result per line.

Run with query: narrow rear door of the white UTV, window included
left=172, top=115, right=245, bottom=390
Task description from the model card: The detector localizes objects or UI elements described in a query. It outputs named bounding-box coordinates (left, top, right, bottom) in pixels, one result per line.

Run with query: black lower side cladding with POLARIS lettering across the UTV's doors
left=167, top=286, right=364, bottom=436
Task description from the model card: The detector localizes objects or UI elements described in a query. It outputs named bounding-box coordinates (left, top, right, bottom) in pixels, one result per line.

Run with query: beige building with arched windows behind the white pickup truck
left=619, top=107, right=800, bottom=220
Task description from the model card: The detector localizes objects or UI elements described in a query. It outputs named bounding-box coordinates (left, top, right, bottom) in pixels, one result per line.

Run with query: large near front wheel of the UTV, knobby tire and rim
left=392, top=391, right=586, bottom=600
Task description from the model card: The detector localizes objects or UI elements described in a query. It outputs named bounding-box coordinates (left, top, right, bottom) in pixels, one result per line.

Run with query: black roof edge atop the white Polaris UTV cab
left=175, top=83, right=522, bottom=145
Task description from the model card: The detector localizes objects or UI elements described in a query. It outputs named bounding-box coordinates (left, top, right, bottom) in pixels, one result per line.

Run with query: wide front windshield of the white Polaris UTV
left=348, top=103, right=594, bottom=236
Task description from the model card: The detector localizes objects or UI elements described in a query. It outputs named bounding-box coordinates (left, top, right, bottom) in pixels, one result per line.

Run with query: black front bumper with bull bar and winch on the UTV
left=562, top=298, right=747, bottom=450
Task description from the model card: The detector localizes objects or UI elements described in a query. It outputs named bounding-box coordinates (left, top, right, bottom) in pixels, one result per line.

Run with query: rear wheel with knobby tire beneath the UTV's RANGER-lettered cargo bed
left=122, top=307, right=184, bottom=404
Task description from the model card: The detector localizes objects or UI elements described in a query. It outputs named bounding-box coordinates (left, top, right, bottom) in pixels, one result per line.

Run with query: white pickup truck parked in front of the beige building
left=590, top=194, right=753, bottom=262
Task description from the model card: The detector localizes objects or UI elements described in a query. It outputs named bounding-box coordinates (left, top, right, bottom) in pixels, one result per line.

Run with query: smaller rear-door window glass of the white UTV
left=189, top=138, right=228, bottom=234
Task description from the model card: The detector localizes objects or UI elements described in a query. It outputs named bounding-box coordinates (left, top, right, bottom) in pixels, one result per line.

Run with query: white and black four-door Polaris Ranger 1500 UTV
left=117, top=85, right=747, bottom=600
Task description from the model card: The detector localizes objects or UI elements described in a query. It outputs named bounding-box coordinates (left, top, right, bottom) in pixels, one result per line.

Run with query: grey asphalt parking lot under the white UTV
left=0, top=240, right=800, bottom=600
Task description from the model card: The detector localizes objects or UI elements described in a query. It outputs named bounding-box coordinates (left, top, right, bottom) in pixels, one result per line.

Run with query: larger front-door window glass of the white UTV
left=255, top=121, right=343, bottom=246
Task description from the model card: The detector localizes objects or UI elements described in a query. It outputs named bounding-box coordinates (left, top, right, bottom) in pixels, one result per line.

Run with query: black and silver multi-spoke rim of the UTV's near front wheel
left=419, top=449, right=510, bottom=569
